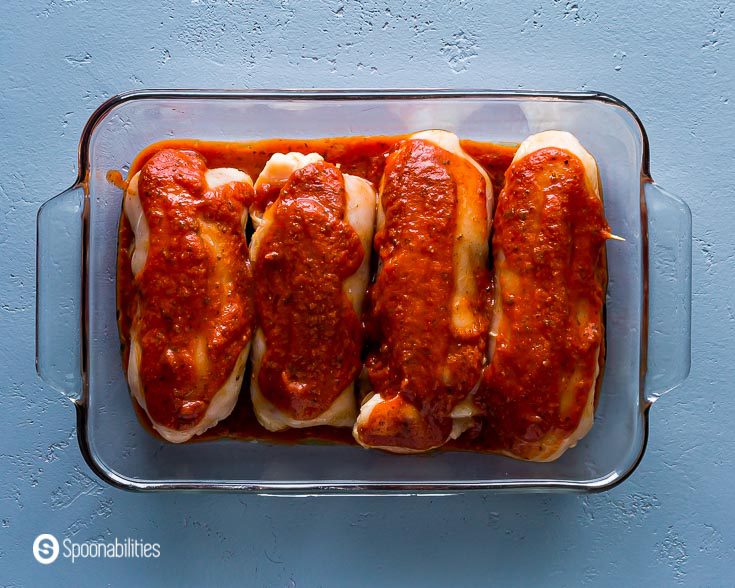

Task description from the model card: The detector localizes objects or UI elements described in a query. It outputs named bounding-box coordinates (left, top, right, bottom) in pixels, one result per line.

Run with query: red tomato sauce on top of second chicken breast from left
left=253, top=162, right=365, bottom=420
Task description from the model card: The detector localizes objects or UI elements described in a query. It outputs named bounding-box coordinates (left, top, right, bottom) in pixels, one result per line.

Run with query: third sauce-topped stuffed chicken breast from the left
left=353, top=130, right=492, bottom=453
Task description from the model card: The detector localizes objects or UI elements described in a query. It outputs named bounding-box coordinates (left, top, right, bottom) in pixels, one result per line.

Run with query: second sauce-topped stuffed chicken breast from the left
left=250, top=153, right=376, bottom=431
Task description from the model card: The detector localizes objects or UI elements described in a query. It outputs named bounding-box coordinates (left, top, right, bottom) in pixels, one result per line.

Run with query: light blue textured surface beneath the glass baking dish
left=0, top=0, right=735, bottom=586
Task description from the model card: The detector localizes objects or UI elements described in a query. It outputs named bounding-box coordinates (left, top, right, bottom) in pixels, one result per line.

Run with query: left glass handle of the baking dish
left=36, top=184, right=84, bottom=401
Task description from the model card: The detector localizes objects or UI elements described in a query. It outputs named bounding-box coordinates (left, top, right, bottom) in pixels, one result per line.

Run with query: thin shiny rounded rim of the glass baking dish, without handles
left=67, top=88, right=653, bottom=496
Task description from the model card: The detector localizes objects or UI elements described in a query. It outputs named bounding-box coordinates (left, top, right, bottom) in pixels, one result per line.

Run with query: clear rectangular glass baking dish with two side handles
left=36, top=90, right=691, bottom=494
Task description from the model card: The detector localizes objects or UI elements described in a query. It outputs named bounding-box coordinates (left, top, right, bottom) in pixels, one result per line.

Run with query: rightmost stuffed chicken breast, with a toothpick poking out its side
left=478, top=131, right=610, bottom=461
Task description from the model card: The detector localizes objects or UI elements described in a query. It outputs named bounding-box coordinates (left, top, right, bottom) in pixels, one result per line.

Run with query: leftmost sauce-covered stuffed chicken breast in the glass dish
left=124, top=149, right=254, bottom=443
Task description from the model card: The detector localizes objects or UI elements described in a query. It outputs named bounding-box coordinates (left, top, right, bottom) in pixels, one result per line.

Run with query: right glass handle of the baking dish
left=644, top=180, right=692, bottom=403
